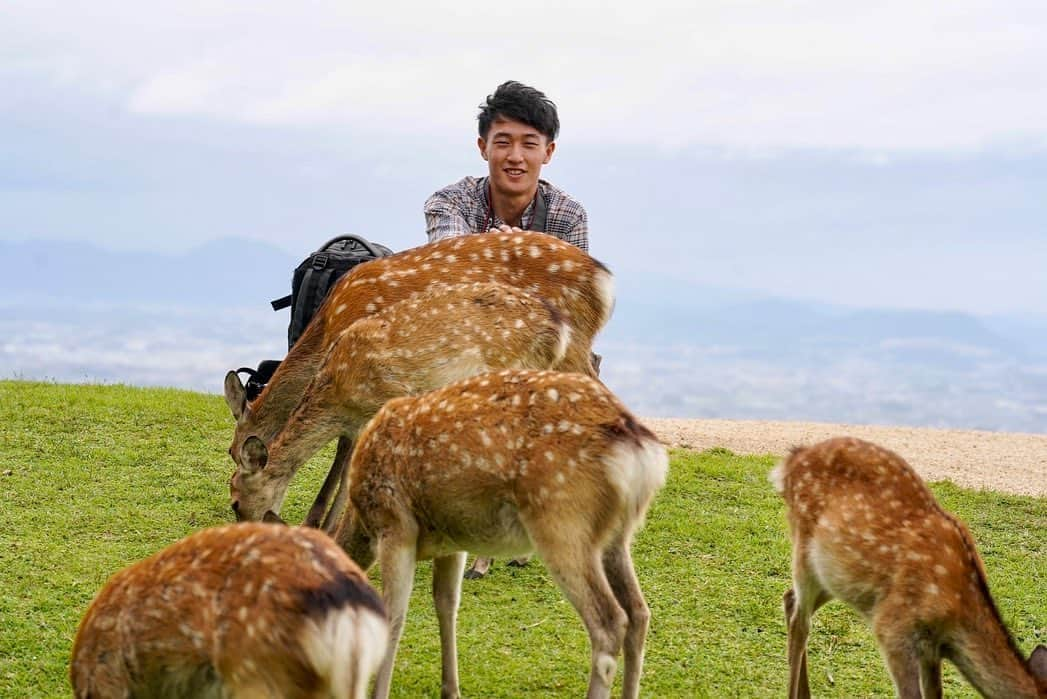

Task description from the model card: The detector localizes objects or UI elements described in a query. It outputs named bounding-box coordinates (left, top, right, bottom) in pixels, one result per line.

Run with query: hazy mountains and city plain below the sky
left=0, top=234, right=1047, bottom=432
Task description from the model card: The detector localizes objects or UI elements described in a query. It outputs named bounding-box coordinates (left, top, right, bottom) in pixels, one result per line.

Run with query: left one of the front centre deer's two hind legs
left=535, top=537, right=628, bottom=699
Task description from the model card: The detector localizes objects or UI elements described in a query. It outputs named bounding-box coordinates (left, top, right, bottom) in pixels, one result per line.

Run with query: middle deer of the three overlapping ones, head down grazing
left=230, top=281, right=571, bottom=525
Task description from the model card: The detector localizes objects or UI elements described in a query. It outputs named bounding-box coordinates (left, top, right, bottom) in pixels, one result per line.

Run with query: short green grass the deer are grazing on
left=0, top=381, right=1047, bottom=698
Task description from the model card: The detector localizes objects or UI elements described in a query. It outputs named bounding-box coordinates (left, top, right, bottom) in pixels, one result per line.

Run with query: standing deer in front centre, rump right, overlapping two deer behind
left=246, top=369, right=668, bottom=699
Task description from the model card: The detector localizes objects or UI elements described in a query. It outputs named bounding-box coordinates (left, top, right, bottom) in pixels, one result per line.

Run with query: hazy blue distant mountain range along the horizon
left=8, top=239, right=1047, bottom=368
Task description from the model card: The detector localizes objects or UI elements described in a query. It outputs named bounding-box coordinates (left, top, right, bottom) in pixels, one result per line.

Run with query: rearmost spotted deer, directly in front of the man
left=225, top=231, right=615, bottom=527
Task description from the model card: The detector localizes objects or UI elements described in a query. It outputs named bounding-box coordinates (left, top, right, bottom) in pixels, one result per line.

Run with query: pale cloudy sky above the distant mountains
left=0, top=0, right=1047, bottom=314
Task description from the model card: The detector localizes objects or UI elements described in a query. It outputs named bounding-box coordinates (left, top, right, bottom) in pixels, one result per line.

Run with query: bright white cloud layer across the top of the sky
left=6, top=0, right=1047, bottom=151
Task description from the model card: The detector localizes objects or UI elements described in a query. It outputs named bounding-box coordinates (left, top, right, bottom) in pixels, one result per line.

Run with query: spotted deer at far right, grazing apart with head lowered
left=770, top=437, right=1047, bottom=699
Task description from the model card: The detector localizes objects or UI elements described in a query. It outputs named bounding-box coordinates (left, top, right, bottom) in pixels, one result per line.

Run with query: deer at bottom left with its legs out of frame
left=69, top=523, right=388, bottom=699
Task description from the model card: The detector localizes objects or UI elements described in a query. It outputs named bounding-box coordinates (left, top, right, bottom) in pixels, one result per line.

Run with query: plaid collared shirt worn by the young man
left=425, top=177, right=588, bottom=252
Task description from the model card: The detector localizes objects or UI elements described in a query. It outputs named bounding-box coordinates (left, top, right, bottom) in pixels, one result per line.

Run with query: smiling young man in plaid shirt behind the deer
left=425, top=81, right=588, bottom=251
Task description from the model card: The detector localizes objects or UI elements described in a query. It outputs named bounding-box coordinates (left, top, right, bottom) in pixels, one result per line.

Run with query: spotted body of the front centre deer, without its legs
left=336, top=370, right=668, bottom=564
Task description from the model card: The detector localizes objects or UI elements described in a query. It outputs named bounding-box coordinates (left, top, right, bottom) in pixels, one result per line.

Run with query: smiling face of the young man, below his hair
left=476, top=117, right=556, bottom=196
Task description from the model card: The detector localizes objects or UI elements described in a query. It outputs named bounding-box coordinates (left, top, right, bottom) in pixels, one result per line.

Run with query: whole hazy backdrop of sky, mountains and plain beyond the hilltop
left=0, top=0, right=1047, bottom=432
